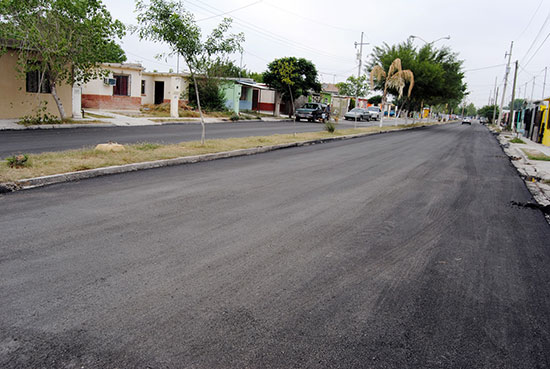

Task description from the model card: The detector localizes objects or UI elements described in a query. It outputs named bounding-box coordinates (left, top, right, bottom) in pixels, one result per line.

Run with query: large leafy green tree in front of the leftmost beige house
left=0, top=0, right=126, bottom=119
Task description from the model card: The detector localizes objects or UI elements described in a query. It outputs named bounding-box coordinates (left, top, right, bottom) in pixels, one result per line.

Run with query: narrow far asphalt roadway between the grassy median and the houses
left=0, top=122, right=328, bottom=158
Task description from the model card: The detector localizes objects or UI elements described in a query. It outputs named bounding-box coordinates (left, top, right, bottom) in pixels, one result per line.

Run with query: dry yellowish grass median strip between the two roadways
left=0, top=123, right=438, bottom=183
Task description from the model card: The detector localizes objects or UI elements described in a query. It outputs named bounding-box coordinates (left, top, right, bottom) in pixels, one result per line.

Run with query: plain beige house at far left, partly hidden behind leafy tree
left=0, top=49, right=74, bottom=119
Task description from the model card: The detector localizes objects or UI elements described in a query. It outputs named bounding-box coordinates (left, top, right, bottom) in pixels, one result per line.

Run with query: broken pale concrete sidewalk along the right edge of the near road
left=498, top=132, right=550, bottom=206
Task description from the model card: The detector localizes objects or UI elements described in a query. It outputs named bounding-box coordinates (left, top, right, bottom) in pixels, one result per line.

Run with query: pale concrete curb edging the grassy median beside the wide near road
left=0, top=125, right=444, bottom=193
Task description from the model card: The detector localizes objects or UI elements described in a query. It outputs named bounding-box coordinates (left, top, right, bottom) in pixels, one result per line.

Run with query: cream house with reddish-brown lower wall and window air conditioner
left=82, top=63, right=189, bottom=110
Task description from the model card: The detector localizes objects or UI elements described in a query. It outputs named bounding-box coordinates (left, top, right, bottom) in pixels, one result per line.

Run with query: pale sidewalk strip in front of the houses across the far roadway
left=0, top=109, right=289, bottom=131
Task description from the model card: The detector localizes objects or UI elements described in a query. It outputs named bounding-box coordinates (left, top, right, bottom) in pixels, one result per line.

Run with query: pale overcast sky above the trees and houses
left=104, top=0, right=550, bottom=107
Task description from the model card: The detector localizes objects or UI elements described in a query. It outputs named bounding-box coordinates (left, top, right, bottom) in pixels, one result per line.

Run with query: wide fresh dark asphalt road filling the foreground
left=0, top=124, right=550, bottom=368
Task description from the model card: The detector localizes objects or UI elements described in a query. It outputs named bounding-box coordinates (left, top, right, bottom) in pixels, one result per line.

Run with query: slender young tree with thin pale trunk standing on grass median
left=136, top=0, right=244, bottom=145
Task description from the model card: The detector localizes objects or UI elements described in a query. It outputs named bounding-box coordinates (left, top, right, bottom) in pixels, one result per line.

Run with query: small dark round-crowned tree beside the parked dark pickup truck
left=264, top=57, right=321, bottom=115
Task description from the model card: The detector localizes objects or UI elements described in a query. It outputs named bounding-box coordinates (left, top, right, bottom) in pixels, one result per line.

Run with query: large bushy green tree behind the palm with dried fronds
left=366, top=40, right=466, bottom=110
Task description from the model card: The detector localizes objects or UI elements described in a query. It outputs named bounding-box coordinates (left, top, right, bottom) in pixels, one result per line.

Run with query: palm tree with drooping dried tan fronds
left=370, top=58, right=414, bottom=127
